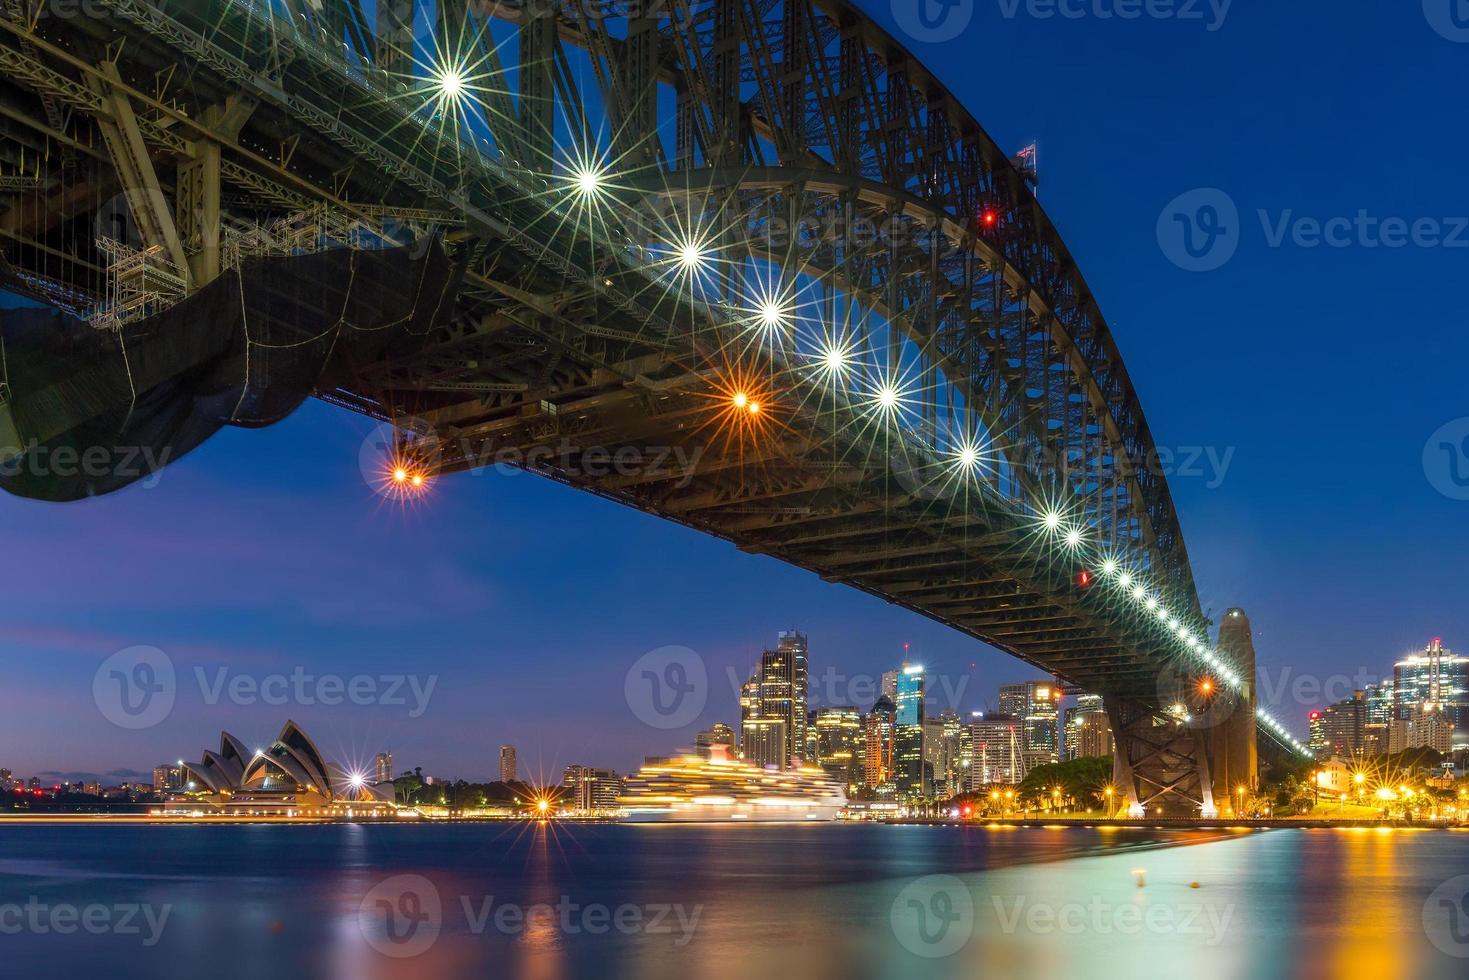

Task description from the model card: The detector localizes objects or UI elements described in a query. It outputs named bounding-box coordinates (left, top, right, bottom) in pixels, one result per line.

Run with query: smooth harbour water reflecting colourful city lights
left=0, top=824, right=1469, bottom=980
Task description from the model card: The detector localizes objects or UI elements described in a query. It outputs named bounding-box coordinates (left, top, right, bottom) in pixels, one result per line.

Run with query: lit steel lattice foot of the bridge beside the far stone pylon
left=1105, top=696, right=1219, bottom=818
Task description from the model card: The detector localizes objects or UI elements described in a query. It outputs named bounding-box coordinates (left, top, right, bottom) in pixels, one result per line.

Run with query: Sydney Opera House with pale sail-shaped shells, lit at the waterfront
left=166, top=721, right=395, bottom=817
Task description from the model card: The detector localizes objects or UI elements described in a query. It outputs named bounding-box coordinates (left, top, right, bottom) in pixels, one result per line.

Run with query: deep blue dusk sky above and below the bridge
left=0, top=0, right=1469, bottom=779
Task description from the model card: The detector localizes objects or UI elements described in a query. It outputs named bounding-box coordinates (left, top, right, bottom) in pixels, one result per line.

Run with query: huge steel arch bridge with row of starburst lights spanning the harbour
left=0, top=0, right=1300, bottom=815
